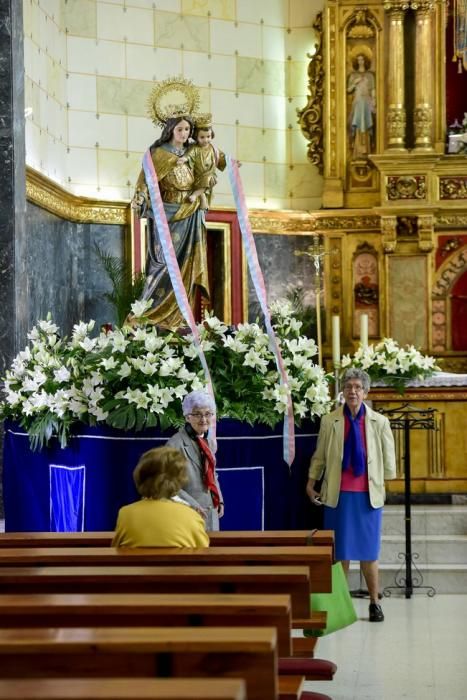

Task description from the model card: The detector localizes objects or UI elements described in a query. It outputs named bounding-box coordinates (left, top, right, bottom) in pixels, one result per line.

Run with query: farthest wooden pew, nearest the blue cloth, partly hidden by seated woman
left=0, top=530, right=334, bottom=548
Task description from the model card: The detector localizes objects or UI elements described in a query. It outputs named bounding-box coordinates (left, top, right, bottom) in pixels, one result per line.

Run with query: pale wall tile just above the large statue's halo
left=126, top=44, right=183, bottom=81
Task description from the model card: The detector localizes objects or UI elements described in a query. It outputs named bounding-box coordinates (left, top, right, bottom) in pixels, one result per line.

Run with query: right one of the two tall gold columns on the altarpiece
left=410, top=0, right=434, bottom=151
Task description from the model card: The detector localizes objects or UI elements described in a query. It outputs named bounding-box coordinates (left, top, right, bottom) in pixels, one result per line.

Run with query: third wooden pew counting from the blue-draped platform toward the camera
left=0, top=566, right=310, bottom=618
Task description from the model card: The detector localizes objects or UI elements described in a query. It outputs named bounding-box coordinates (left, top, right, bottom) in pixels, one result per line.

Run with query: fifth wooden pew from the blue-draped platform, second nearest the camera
left=0, top=627, right=278, bottom=700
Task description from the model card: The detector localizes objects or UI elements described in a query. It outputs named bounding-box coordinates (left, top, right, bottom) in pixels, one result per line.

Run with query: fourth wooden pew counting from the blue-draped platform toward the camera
left=0, top=593, right=296, bottom=656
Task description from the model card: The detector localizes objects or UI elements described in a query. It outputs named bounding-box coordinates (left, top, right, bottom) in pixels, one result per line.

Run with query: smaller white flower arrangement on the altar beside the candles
left=341, top=338, right=440, bottom=394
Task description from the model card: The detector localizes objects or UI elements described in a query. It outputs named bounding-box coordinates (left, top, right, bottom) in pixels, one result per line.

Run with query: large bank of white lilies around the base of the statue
left=0, top=301, right=331, bottom=448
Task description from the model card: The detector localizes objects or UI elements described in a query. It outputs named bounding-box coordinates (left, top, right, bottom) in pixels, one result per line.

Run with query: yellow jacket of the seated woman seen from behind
left=112, top=499, right=209, bottom=547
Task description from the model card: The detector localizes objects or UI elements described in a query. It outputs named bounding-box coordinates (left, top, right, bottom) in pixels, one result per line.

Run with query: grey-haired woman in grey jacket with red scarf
left=167, top=391, right=224, bottom=531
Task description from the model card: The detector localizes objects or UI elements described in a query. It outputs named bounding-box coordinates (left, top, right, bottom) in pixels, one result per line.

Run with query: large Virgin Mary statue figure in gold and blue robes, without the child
left=132, top=115, right=209, bottom=330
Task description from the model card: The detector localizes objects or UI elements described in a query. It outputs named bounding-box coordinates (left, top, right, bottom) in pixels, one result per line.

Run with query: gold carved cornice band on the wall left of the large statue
left=26, top=167, right=130, bottom=225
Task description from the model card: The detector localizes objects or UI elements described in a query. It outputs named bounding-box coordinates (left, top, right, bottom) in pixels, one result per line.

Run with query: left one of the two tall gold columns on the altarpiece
left=384, top=0, right=409, bottom=151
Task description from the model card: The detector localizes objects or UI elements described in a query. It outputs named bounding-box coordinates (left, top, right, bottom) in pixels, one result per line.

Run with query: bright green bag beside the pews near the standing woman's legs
left=303, top=562, right=357, bottom=637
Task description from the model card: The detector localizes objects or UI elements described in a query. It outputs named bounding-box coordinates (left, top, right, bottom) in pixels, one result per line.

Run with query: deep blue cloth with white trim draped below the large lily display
left=3, top=419, right=321, bottom=532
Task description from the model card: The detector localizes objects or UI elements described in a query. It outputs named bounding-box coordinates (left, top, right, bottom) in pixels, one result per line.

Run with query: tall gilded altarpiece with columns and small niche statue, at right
left=299, top=0, right=467, bottom=492
